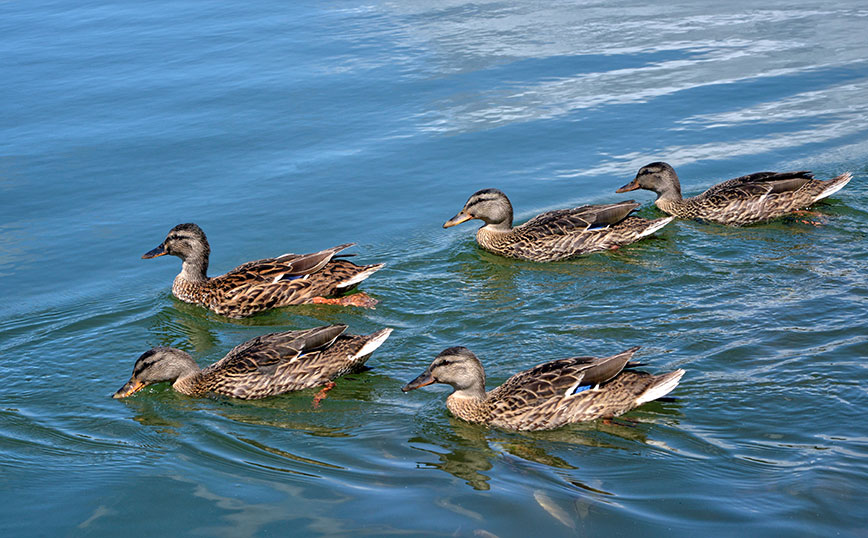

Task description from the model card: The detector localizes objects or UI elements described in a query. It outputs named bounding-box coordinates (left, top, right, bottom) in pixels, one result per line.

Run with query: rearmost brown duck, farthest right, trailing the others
left=615, top=162, right=853, bottom=226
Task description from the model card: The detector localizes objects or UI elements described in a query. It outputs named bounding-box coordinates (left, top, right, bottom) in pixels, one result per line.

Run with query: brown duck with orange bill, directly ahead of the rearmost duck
left=443, top=189, right=672, bottom=262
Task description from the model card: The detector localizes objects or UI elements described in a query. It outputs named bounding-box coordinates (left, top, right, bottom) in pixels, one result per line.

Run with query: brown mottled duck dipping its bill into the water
left=114, top=325, right=392, bottom=402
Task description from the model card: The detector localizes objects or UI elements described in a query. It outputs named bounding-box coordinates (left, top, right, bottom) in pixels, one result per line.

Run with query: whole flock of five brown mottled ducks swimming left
left=114, top=162, right=851, bottom=430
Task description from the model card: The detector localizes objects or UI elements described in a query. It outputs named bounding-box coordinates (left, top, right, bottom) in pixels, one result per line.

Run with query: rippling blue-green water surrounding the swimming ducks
left=0, top=1, right=868, bottom=536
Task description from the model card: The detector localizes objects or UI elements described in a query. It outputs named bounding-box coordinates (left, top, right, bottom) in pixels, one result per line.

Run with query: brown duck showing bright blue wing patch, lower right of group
left=401, top=347, right=684, bottom=430
